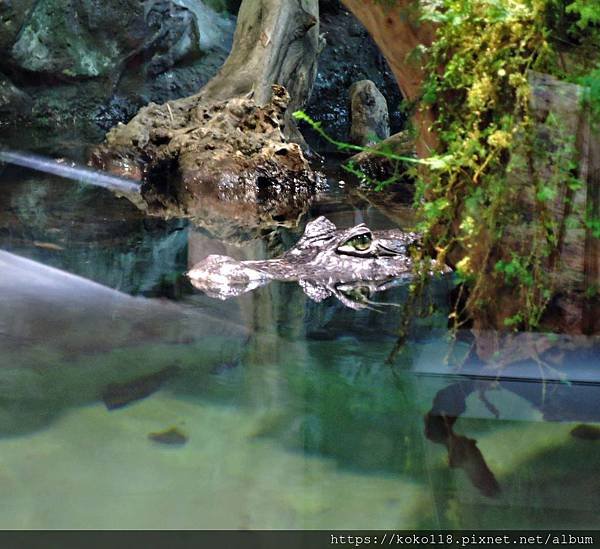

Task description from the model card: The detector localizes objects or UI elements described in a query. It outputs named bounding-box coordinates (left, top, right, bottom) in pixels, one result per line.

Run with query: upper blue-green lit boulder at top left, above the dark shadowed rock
left=12, top=0, right=233, bottom=78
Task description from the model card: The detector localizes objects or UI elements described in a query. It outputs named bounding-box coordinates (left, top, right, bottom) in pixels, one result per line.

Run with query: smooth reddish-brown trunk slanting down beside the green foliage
left=342, top=0, right=438, bottom=157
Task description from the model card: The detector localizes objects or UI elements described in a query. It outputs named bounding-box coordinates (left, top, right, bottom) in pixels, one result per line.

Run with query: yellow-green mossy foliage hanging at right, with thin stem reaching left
left=298, top=0, right=600, bottom=329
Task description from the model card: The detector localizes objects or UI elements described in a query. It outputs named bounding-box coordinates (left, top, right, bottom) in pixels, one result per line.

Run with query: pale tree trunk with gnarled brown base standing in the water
left=91, top=0, right=321, bottom=233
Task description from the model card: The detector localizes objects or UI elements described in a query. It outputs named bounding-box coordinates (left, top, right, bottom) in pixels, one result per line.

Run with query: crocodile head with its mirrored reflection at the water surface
left=188, top=217, right=440, bottom=309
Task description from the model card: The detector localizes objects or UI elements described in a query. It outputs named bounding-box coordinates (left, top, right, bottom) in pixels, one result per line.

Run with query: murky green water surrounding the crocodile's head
left=0, top=153, right=600, bottom=529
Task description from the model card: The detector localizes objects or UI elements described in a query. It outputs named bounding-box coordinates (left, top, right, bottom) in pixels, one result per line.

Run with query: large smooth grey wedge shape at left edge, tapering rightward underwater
left=0, top=251, right=249, bottom=435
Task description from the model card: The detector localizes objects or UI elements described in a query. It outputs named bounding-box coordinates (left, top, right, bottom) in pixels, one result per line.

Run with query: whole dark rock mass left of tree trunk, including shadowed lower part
left=0, top=0, right=235, bottom=134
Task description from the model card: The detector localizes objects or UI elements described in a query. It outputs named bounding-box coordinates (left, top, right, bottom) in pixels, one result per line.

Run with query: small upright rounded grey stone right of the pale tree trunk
left=350, top=80, right=390, bottom=146
